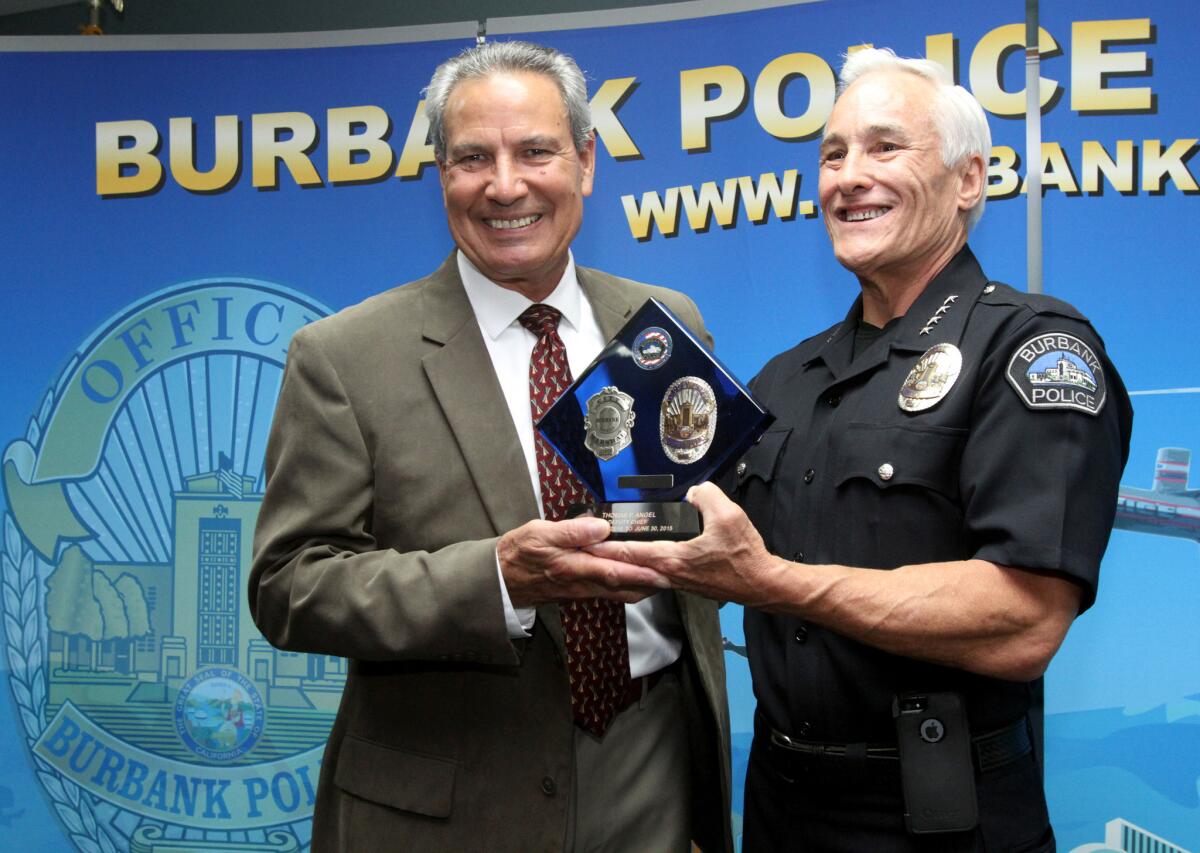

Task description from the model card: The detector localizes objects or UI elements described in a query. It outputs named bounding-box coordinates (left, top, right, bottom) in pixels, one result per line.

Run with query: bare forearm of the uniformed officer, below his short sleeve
left=760, top=558, right=1080, bottom=680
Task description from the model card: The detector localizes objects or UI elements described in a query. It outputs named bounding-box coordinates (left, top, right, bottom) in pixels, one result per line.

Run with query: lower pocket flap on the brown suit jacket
left=334, top=737, right=457, bottom=817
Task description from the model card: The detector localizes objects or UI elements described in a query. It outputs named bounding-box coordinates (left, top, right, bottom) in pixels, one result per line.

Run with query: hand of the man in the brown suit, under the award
left=496, top=518, right=671, bottom=607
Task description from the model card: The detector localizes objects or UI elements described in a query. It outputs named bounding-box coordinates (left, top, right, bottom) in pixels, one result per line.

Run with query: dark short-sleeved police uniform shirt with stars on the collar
left=733, top=247, right=1133, bottom=743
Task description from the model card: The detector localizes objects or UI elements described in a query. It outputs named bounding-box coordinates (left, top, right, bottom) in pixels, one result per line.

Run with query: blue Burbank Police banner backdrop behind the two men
left=0, top=0, right=1200, bottom=851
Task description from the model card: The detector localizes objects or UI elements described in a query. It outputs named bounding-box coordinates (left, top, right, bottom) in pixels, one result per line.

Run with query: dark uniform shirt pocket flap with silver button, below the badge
left=838, top=424, right=967, bottom=500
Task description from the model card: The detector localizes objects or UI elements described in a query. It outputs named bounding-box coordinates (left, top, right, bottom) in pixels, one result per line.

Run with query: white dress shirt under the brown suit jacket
left=457, top=252, right=683, bottom=678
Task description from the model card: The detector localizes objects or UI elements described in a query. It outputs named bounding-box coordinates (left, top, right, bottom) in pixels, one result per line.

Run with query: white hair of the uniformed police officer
left=838, top=48, right=991, bottom=230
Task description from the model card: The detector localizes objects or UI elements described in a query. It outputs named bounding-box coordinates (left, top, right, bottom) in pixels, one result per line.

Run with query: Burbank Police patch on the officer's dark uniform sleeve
left=1004, top=331, right=1106, bottom=415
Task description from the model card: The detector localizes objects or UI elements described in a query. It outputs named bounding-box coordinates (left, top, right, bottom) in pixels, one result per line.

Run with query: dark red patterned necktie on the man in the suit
left=520, top=304, right=631, bottom=737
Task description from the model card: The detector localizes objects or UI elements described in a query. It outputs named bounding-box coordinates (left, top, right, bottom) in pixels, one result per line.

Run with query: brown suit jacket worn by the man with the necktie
left=250, top=254, right=732, bottom=853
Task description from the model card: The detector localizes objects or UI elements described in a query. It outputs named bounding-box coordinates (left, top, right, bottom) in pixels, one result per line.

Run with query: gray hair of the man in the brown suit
left=425, top=41, right=592, bottom=162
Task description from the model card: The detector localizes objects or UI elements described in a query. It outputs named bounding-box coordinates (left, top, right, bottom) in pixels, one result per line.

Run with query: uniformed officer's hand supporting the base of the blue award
left=588, top=482, right=780, bottom=607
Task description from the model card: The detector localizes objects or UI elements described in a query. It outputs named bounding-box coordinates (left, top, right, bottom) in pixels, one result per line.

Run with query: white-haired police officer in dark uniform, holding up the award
left=601, top=49, right=1132, bottom=853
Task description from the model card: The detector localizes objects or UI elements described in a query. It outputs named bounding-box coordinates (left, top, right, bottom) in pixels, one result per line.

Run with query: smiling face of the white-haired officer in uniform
left=818, top=70, right=982, bottom=287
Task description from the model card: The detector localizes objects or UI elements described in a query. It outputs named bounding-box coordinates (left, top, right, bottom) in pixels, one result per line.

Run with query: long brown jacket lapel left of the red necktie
left=421, top=260, right=538, bottom=534
